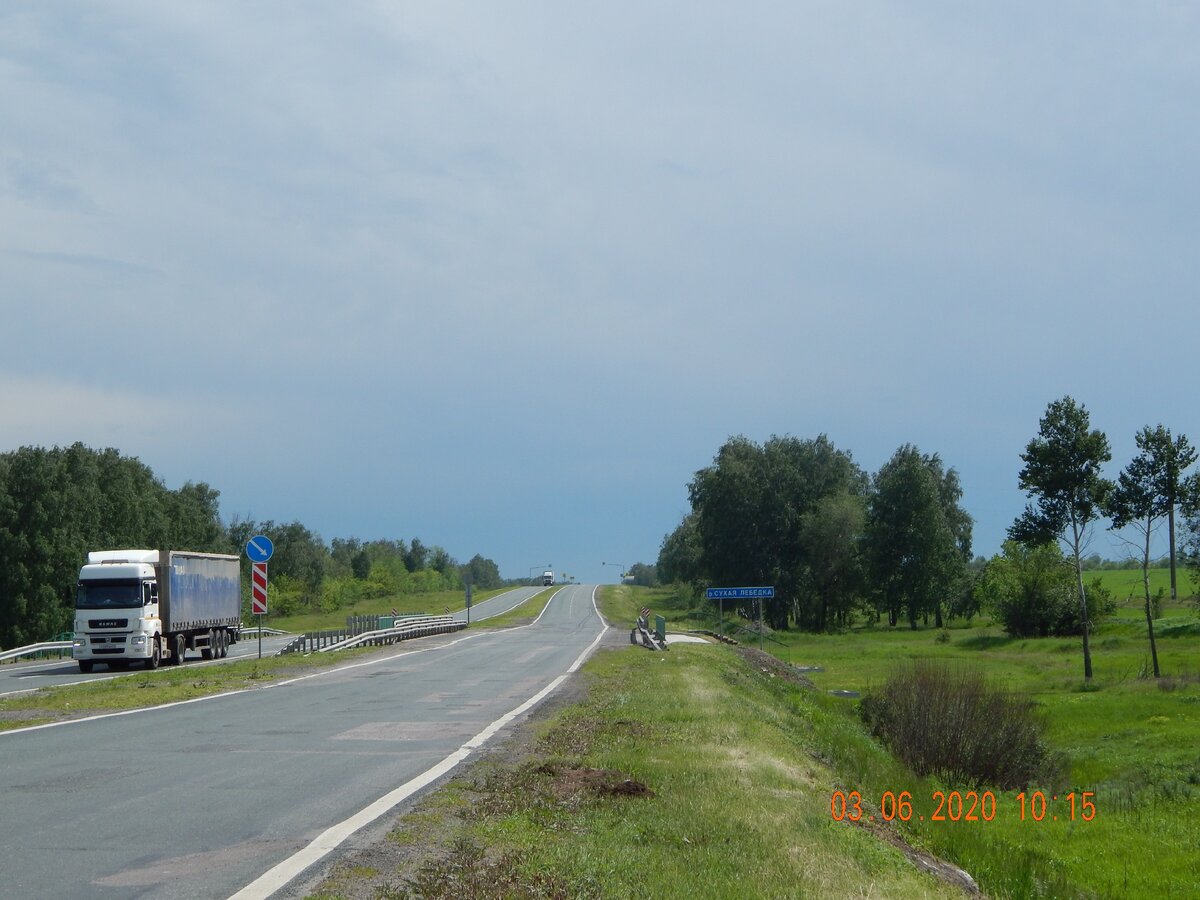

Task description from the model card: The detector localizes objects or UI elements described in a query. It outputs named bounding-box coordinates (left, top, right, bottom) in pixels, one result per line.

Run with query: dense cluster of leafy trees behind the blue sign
left=656, top=434, right=972, bottom=631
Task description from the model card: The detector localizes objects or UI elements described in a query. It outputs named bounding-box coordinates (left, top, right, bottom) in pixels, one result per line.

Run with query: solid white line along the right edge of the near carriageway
left=229, top=588, right=608, bottom=900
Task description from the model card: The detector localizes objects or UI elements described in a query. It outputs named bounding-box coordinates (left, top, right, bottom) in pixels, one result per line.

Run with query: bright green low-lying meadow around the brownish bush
left=614, top=585, right=1200, bottom=896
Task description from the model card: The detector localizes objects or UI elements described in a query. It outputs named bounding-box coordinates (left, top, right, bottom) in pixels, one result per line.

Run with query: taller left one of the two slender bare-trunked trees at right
left=1008, top=397, right=1112, bottom=680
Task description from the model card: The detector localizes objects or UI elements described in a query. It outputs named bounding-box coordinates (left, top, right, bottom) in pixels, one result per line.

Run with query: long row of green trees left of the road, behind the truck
left=0, top=443, right=504, bottom=647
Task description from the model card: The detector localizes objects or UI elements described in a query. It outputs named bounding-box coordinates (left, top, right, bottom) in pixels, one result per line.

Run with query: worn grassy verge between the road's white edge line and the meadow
left=390, top=643, right=960, bottom=899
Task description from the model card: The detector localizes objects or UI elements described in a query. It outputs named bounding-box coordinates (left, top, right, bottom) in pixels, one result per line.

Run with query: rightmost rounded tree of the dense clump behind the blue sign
left=865, top=444, right=971, bottom=629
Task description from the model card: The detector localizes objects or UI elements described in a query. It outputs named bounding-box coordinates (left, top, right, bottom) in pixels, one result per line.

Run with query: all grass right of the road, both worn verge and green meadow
left=304, top=573, right=1200, bottom=898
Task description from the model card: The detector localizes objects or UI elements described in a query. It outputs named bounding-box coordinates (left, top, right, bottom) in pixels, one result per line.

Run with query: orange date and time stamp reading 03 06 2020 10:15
left=829, top=791, right=1097, bottom=822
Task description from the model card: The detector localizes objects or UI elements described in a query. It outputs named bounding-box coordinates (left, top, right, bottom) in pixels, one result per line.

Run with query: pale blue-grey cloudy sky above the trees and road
left=0, top=0, right=1200, bottom=582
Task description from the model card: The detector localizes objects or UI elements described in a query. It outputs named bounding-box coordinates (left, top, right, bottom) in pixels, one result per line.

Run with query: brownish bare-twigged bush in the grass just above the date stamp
left=859, top=660, right=1066, bottom=790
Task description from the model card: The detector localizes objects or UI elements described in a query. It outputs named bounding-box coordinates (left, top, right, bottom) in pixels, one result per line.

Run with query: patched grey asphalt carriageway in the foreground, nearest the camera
left=0, top=586, right=604, bottom=900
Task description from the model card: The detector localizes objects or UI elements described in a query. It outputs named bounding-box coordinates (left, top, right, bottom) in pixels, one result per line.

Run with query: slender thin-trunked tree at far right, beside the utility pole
left=1108, top=425, right=1195, bottom=678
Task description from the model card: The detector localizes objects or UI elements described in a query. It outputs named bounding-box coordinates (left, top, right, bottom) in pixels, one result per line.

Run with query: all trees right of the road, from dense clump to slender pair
left=654, top=397, right=1200, bottom=678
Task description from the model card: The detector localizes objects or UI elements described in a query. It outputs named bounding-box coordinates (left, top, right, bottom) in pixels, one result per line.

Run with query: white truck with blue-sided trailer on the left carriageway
left=71, top=550, right=241, bottom=672
